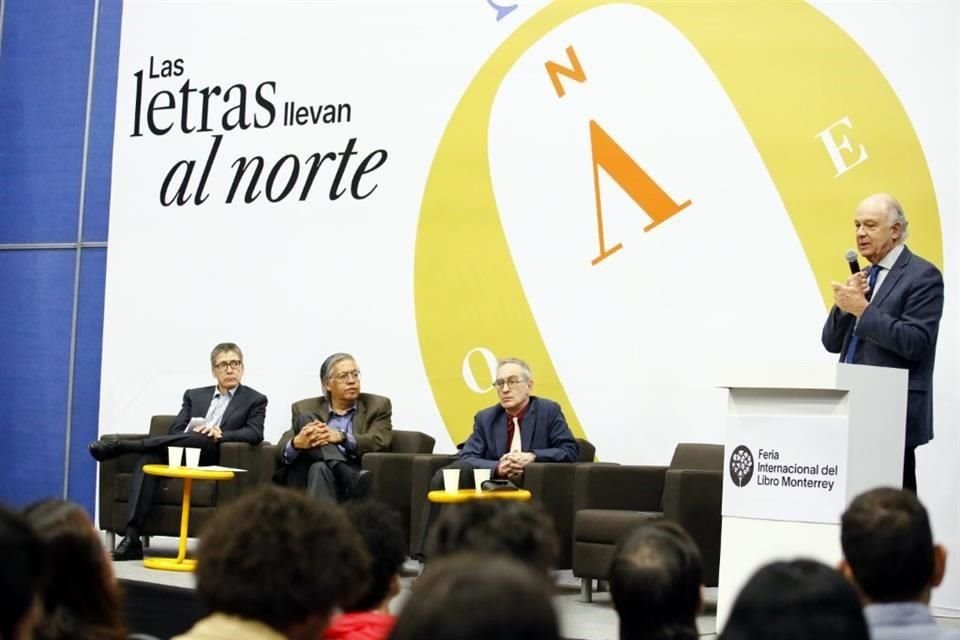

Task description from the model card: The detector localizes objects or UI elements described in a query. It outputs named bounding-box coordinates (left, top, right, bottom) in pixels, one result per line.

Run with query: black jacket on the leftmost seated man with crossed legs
left=170, top=385, right=267, bottom=445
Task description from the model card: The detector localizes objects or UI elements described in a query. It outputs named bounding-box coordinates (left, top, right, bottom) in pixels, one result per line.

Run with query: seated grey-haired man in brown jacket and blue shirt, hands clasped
left=273, top=353, right=393, bottom=502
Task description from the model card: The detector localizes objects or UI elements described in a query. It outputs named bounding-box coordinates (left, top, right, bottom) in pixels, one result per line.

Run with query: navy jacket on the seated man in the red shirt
left=458, top=396, right=580, bottom=470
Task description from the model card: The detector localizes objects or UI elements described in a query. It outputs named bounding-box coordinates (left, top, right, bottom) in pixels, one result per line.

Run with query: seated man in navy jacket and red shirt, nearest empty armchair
left=419, top=358, right=580, bottom=555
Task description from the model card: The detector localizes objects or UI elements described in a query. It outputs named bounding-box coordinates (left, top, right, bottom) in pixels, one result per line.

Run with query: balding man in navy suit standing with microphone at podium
left=821, top=193, right=943, bottom=493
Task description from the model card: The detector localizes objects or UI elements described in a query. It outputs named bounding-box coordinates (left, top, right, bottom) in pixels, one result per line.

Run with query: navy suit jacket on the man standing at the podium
left=821, top=247, right=943, bottom=447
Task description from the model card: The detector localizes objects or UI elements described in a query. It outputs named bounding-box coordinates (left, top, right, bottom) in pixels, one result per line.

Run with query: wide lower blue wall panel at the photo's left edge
left=0, top=250, right=76, bottom=505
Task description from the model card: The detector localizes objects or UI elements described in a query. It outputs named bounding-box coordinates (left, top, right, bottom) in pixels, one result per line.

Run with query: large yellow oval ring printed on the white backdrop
left=414, top=1, right=943, bottom=442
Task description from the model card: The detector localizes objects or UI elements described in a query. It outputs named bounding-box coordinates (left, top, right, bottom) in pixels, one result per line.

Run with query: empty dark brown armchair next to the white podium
left=573, top=443, right=723, bottom=602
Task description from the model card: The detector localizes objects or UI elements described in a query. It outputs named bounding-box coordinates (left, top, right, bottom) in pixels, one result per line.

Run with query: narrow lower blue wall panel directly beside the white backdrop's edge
left=67, top=249, right=107, bottom=514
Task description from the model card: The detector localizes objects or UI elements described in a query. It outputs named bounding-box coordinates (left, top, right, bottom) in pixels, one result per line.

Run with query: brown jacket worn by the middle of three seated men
left=277, top=393, right=393, bottom=462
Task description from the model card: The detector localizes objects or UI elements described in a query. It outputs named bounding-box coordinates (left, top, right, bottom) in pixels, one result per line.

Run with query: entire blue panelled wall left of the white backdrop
left=0, top=0, right=122, bottom=512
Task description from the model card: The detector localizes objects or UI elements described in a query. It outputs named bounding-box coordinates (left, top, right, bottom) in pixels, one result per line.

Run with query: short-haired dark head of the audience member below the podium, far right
left=840, top=488, right=946, bottom=602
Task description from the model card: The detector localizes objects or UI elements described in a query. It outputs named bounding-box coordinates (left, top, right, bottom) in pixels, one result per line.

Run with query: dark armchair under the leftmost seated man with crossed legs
left=99, top=416, right=267, bottom=548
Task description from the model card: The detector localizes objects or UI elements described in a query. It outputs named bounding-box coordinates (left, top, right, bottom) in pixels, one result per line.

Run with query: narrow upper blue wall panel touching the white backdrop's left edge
left=83, top=0, right=123, bottom=242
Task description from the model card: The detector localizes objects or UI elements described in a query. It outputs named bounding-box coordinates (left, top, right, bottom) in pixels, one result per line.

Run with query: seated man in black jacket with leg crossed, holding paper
left=88, top=342, right=267, bottom=560
